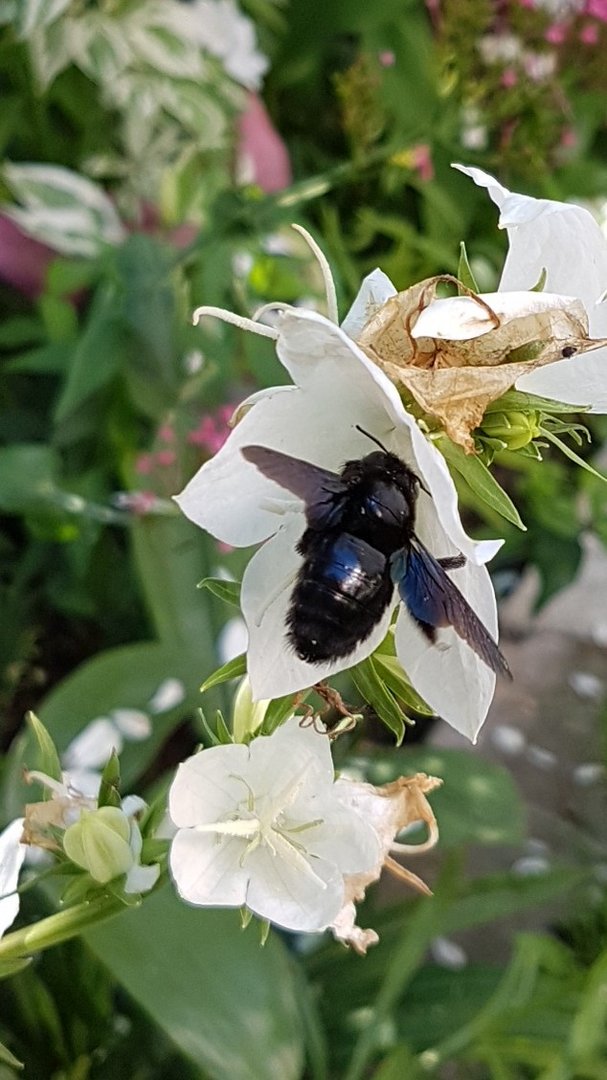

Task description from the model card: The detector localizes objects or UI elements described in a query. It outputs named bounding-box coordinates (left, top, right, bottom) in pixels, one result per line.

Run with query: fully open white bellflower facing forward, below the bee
left=168, top=716, right=380, bottom=932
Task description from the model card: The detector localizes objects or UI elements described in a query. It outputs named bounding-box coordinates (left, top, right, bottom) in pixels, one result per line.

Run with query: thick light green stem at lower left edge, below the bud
left=0, top=895, right=124, bottom=966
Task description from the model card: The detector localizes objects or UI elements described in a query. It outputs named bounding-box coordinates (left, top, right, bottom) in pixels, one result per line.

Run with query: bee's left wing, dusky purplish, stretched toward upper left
left=241, top=446, right=348, bottom=528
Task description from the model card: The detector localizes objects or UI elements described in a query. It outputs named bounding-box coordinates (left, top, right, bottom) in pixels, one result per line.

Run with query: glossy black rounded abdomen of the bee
left=286, top=534, right=393, bottom=663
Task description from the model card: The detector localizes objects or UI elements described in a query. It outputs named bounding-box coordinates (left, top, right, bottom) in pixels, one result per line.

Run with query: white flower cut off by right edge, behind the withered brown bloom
left=456, top=165, right=607, bottom=413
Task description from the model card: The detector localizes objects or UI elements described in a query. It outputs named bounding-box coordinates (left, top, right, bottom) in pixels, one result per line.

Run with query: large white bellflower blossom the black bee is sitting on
left=176, top=231, right=501, bottom=739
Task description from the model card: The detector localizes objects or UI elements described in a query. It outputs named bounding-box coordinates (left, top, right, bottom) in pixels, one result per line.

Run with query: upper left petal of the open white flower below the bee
left=168, top=744, right=248, bottom=828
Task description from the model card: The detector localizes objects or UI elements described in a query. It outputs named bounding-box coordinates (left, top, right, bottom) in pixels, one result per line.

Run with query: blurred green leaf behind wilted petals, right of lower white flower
left=356, top=746, right=524, bottom=848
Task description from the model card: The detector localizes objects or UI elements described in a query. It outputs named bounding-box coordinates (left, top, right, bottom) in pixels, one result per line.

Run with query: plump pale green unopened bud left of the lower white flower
left=64, top=807, right=134, bottom=885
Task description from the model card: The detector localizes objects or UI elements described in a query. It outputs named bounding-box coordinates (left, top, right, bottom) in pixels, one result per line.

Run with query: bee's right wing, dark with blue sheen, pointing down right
left=391, top=539, right=510, bottom=675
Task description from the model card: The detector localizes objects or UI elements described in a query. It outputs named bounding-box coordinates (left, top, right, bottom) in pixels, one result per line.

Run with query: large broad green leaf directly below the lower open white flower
left=85, top=888, right=304, bottom=1080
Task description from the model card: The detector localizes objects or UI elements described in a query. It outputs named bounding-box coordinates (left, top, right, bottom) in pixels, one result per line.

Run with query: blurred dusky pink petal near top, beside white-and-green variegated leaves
left=237, top=92, right=292, bottom=193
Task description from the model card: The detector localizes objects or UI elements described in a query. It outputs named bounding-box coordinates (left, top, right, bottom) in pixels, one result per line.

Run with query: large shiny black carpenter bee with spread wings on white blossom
left=241, top=429, right=510, bottom=674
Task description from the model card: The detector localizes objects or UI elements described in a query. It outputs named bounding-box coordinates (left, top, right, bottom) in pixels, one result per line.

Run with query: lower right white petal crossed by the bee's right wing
left=395, top=563, right=497, bottom=742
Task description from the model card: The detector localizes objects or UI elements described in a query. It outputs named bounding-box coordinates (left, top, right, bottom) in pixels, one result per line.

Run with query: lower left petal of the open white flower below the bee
left=170, top=829, right=248, bottom=907
